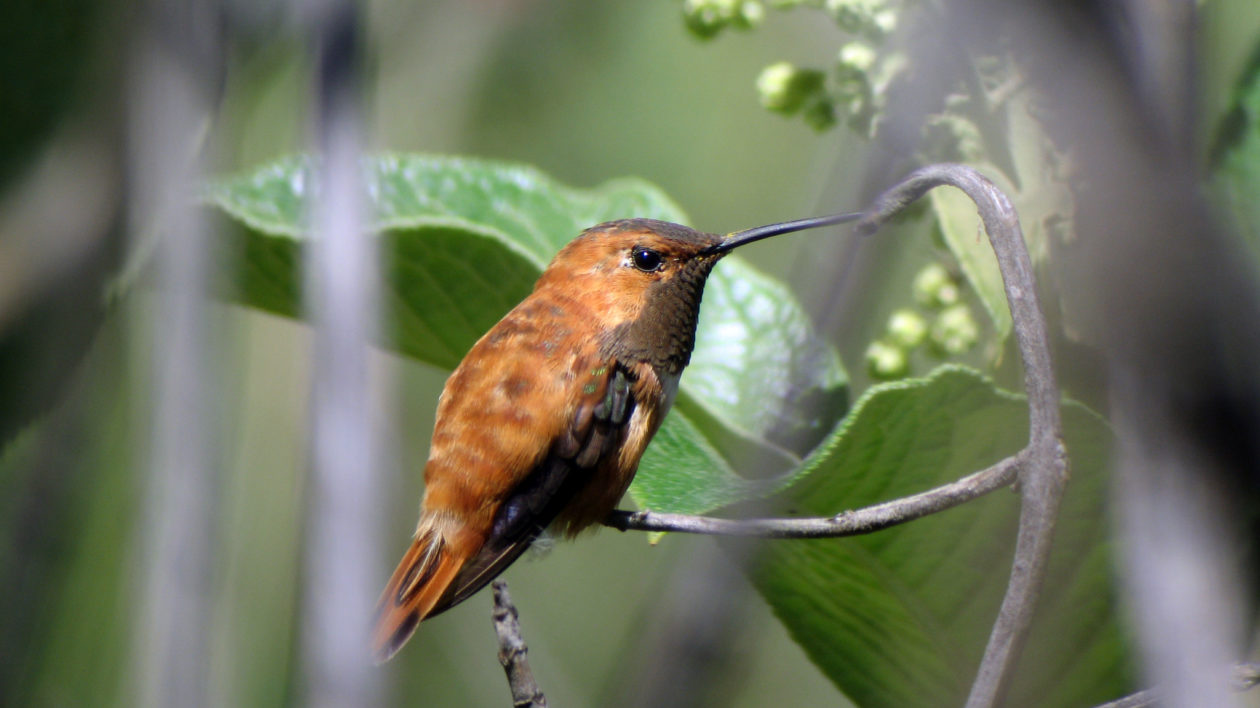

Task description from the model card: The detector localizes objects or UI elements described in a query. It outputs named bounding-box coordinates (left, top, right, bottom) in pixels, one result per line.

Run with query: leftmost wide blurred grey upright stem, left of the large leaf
left=129, top=0, right=221, bottom=707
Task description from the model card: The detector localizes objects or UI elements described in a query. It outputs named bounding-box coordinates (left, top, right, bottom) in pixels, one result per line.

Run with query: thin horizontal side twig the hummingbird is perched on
left=604, top=455, right=1023, bottom=538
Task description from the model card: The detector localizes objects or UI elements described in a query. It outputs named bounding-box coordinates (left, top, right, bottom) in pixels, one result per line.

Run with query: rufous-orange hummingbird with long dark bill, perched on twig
left=372, top=214, right=859, bottom=663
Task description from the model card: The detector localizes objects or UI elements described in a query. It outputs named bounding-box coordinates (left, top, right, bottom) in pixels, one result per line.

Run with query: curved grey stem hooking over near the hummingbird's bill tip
left=858, top=164, right=1067, bottom=708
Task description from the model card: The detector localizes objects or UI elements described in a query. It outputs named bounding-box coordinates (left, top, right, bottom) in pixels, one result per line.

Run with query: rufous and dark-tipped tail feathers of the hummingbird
left=372, top=525, right=466, bottom=664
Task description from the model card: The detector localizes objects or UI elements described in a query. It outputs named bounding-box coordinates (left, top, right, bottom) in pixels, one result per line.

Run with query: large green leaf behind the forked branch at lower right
left=751, top=367, right=1131, bottom=707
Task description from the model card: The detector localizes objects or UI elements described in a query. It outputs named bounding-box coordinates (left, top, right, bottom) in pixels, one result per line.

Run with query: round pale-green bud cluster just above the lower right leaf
left=866, top=263, right=980, bottom=380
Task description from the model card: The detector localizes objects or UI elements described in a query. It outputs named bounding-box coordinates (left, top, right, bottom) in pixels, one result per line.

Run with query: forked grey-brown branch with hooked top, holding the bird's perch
left=605, top=164, right=1067, bottom=708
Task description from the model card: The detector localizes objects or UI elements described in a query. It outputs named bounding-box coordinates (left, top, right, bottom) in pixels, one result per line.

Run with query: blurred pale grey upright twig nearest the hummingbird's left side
left=302, top=0, right=381, bottom=705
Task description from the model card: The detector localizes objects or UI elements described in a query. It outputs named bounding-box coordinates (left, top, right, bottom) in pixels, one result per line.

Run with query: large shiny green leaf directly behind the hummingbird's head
left=207, top=155, right=847, bottom=513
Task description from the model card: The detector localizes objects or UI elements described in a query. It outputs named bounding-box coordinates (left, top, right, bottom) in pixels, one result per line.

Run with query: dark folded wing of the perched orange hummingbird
left=428, top=362, right=635, bottom=616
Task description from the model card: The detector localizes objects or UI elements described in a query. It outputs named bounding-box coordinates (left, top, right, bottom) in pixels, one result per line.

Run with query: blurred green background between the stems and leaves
left=7, top=0, right=1260, bottom=707
